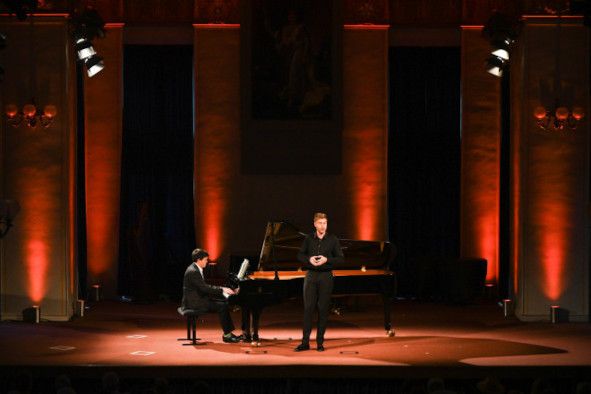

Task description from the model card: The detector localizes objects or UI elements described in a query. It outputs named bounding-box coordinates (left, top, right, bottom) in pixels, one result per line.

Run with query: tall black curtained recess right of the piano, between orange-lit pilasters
left=388, top=47, right=461, bottom=296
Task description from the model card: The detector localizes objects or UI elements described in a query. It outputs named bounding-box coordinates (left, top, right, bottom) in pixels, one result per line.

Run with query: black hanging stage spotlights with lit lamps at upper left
left=70, top=8, right=105, bottom=77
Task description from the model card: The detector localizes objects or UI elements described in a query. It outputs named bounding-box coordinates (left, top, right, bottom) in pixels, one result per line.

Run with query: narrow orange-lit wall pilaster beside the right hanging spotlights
left=460, top=28, right=501, bottom=283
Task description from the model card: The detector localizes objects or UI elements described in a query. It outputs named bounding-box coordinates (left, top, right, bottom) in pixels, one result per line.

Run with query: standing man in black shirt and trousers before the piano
left=294, top=212, right=343, bottom=352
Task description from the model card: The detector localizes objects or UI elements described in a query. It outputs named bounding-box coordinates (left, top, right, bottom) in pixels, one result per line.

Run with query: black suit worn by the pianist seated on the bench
left=181, top=263, right=234, bottom=334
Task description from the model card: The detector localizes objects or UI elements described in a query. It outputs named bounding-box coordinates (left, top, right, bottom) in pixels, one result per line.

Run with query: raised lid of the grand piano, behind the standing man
left=258, top=221, right=395, bottom=271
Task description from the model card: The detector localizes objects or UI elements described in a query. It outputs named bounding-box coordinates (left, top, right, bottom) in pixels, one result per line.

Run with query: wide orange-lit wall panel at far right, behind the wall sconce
left=512, top=18, right=589, bottom=320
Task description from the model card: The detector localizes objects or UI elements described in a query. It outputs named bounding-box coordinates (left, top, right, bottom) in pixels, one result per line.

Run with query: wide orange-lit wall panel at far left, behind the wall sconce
left=0, top=17, right=75, bottom=320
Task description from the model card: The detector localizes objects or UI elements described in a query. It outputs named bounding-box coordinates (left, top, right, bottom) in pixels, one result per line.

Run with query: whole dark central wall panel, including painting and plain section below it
left=240, top=0, right=343, bottom=174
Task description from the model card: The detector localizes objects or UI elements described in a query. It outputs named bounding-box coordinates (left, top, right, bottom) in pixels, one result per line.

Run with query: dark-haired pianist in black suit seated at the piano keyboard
left=179, top=249, right=242, bottom=343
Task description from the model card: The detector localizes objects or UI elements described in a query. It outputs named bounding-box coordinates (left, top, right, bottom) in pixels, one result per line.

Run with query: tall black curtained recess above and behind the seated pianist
left=119, top=45, right=195, bottom=301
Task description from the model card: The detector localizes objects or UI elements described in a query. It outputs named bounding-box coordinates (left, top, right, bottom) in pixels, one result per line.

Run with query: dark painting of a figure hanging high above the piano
left=241, top=0, right=340, bottom=120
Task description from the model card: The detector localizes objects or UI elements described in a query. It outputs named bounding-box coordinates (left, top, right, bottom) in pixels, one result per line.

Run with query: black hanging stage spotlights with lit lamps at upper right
left=482, top=11, right=520, bottom=77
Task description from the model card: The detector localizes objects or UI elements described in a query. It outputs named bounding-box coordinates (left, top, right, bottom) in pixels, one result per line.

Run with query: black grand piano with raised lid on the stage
left=230, top=221, right=396, bottom=343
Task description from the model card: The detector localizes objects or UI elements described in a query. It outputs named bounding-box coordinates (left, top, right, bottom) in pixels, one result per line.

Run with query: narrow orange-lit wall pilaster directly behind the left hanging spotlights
left=84, top=25, right=123, bottom=298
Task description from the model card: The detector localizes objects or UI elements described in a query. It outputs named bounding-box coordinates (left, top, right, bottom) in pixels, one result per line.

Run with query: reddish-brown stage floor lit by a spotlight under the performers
left=0, top=300, right=591, bottom=378
